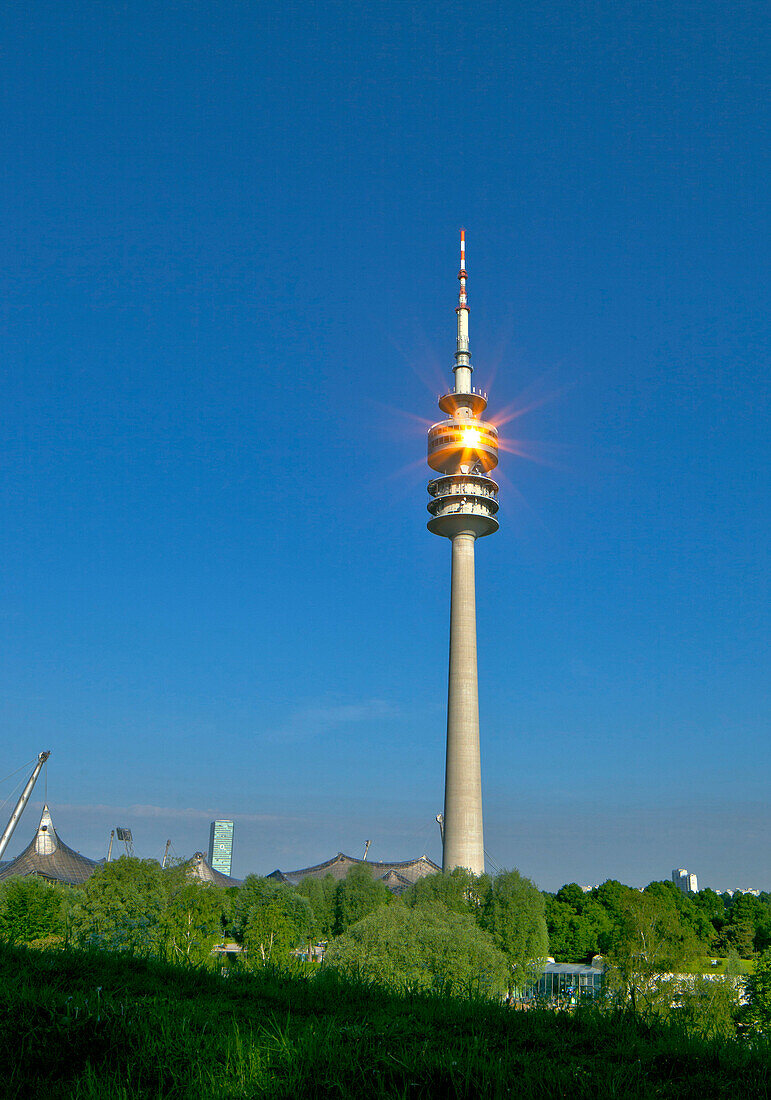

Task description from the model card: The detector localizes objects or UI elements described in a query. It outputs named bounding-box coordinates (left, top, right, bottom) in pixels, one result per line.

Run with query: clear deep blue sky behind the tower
left=0, top=0, right=771, bottom=889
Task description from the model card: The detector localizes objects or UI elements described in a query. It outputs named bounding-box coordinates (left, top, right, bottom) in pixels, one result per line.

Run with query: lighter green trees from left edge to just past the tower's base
left=0, top=857, right=549, bottom=991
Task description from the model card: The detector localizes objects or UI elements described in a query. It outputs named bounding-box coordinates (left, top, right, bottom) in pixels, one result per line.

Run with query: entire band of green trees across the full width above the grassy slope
left=0, top=857, right=771, bottom=988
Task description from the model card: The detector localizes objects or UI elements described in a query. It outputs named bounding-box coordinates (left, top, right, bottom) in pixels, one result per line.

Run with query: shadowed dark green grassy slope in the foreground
left=0, top=947, right=771, bottom=1100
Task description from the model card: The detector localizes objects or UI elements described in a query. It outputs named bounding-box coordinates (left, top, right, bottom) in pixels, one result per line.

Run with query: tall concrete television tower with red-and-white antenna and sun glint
left=428, top=230, right=498, bottom=875
